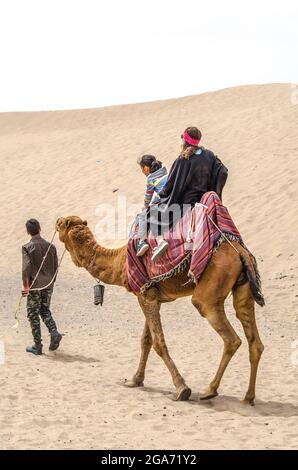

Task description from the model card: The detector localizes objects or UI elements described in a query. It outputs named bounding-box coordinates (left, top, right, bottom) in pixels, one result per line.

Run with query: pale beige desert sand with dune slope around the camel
left=0, top=84, right=298, bottom=449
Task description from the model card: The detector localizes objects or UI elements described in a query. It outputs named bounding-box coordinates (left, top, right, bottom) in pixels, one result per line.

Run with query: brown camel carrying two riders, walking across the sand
left=56, top=216, right=264, bottom=405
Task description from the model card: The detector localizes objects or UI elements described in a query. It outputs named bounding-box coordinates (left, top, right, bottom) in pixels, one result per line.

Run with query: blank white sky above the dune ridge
left=0, top=0, right=298, bottom=111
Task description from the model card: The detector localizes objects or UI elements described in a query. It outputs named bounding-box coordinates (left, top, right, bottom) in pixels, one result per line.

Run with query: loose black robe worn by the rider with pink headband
left=148, top=147, right=228, bottom=236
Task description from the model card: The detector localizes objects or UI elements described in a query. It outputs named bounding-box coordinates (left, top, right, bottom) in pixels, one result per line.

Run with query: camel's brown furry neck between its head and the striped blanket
left=65, top=230, right=128, bottom=287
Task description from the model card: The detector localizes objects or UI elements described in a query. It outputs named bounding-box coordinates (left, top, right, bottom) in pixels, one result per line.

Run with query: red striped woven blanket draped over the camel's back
left=126, top=192, right=242, bottom=293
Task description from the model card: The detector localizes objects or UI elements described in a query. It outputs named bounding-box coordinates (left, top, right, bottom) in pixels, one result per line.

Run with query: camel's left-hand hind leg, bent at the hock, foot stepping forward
left=192, top=291, right=241, bottom=400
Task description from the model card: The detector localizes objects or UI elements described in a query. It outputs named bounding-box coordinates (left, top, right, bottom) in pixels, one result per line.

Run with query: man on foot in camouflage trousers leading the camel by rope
left=22, top=219, right=62, bottom=355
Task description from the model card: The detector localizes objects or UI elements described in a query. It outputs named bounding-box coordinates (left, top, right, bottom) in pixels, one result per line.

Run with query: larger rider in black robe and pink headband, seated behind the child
left=147, top=127, right=228, bottom=261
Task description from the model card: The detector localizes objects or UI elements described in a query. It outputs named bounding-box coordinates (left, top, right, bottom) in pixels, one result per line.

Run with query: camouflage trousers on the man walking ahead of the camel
left=27, top=288, right=57, bottom=344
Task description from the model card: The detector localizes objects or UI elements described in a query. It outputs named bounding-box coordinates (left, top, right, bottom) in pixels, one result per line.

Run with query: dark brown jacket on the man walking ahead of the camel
left=22, top=235, right=58, bottom=288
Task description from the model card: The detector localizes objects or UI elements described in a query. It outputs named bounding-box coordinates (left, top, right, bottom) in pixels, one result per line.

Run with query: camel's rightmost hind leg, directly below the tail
left=233, top=283, right=264, bottom=405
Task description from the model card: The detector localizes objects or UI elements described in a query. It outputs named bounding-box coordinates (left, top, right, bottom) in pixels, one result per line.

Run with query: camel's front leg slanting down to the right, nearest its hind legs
left=138, top=288, right=191, bottom=400
